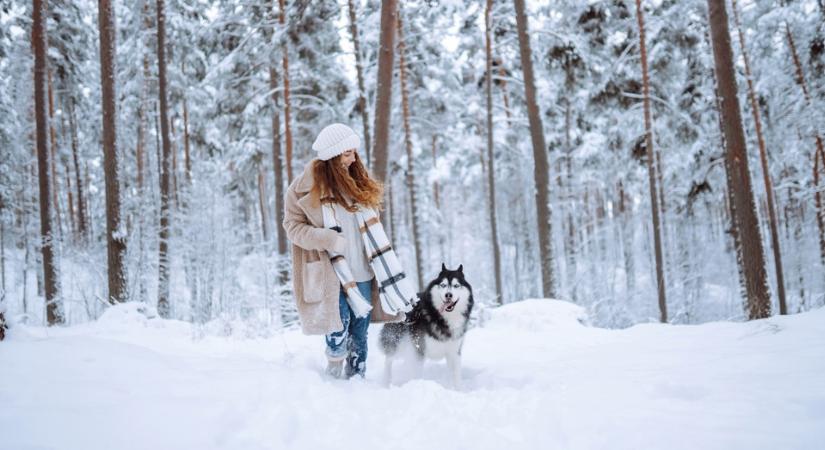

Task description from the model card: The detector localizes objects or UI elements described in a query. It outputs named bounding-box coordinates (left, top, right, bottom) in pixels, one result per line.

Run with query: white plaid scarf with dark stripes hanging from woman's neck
left=321, top=203, right=418, bottom=317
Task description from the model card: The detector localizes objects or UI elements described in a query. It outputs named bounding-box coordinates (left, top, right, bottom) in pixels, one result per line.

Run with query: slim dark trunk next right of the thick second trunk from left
left=157, top=0, right=172, bottom=318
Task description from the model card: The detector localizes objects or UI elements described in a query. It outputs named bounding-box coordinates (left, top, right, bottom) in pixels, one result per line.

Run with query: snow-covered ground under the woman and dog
left=0, top=300, right=825, bottom=450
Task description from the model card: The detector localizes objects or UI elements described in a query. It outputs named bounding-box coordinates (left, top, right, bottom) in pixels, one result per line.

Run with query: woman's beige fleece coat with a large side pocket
left=283, top=160, right=404, bottom=334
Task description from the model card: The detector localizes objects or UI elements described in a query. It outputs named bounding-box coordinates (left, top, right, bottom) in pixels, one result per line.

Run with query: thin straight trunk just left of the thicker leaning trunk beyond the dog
left=484, top=0, right=504, bottom=305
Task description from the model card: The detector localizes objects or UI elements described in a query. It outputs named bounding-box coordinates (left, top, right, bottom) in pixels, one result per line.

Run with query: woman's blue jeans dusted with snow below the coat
left=324, top=280, right=372, bottom=378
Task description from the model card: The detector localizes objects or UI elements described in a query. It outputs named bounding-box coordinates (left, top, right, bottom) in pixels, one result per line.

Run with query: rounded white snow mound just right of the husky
left=486, top=298, right=589, bottom=331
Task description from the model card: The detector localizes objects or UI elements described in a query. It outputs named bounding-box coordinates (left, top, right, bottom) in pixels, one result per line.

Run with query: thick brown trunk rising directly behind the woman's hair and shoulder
left=372, top=0, right=398, bottom=183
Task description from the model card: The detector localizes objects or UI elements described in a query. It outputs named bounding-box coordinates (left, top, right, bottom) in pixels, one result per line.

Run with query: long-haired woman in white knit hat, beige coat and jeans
left=283, top=124, right=403, bottom=378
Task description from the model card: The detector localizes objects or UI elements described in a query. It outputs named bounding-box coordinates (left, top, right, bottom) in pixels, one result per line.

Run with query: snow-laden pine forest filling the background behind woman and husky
left=0, top=0, right=825, bottom=329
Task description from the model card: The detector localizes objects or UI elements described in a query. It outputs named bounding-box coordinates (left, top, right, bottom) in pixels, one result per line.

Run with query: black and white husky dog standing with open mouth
left=380, top=264, right=473, bottom=389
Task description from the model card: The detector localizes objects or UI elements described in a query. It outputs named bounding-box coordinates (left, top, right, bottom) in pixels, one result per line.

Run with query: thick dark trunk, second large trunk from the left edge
left=98, top=0, right=126, bottom=304
